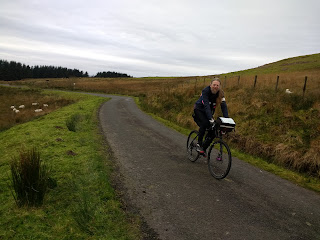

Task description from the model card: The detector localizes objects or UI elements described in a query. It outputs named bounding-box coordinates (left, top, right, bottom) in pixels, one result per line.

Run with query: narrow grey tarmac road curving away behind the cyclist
left=95, top=94, right=320, bottom=240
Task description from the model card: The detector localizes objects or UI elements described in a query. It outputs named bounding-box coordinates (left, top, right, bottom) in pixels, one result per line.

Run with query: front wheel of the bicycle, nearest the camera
left=208, top=139, right=232, bottom=179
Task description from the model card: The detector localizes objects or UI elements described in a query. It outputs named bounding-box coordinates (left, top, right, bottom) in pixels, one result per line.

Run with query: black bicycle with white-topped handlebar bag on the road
left=187, top=117, right=235, bottom=179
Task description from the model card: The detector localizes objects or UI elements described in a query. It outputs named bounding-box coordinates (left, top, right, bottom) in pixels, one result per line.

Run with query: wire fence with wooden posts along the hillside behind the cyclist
left=172, top=72, right=320, bottom=99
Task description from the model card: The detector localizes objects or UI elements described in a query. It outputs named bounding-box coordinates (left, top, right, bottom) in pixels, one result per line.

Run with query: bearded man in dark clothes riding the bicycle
left=193, top=78, right=228, bottom=156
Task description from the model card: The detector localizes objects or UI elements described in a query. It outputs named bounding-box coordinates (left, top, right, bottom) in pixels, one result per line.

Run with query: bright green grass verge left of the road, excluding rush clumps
left=0, top=93, right=140, bottom=239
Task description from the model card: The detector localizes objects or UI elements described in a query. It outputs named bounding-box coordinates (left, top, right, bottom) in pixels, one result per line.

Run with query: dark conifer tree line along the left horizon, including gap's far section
left=0, top=60, right=130, bottom=81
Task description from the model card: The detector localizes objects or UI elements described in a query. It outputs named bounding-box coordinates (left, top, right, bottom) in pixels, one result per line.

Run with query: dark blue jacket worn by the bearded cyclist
left=194, top=86, right=229, bottom=120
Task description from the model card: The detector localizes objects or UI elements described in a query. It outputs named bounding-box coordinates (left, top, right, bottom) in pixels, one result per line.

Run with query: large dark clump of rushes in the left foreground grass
left=10, top=148, right=49, bottom=207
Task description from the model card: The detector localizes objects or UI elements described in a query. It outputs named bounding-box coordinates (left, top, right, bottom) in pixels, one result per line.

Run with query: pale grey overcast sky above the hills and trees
left=0, top=0, right=320, bottom=77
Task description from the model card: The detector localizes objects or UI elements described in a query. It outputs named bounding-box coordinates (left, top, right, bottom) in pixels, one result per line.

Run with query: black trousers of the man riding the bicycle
left=194, top=109, right=214, bottom=149
